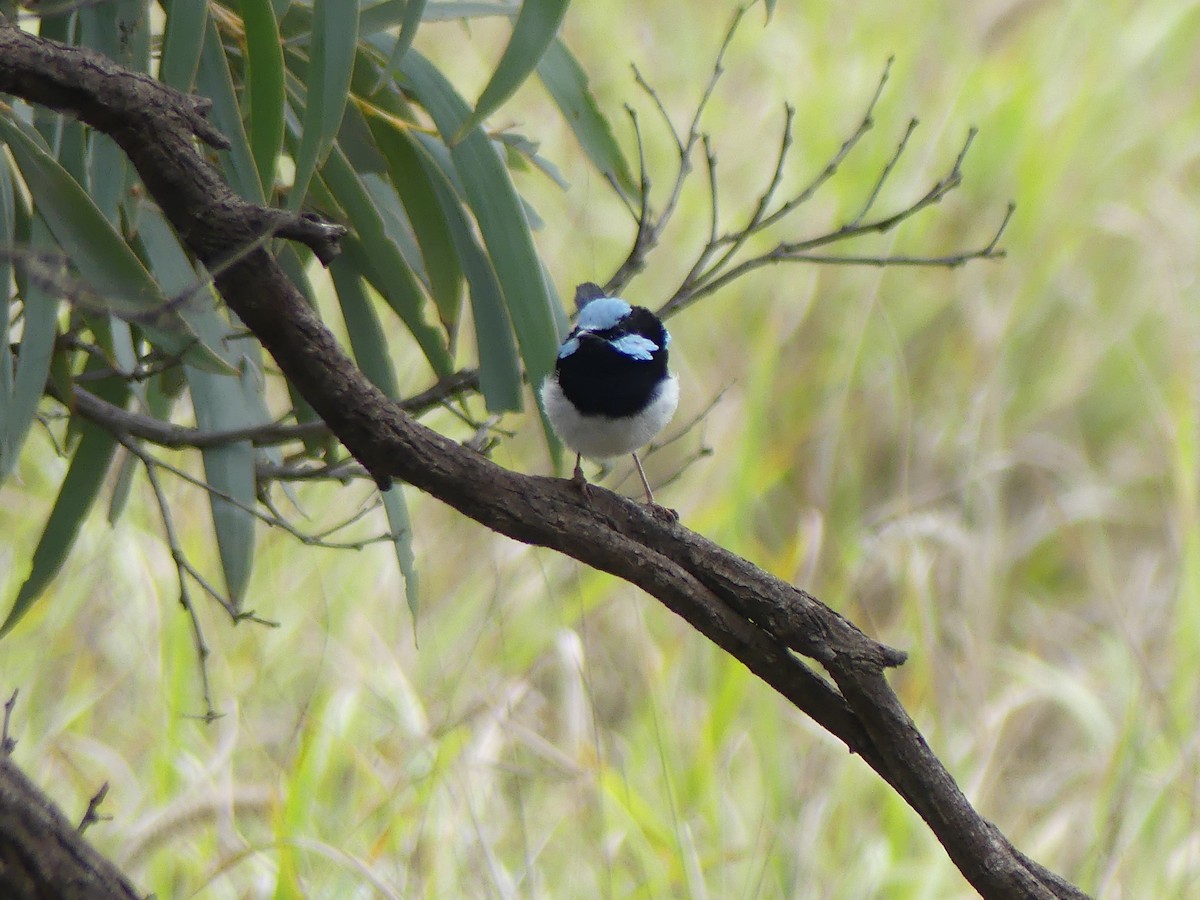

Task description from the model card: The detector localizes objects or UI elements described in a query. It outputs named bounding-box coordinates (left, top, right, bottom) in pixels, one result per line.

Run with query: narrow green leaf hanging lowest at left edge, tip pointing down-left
left=0, top=380, right=126, bottom=637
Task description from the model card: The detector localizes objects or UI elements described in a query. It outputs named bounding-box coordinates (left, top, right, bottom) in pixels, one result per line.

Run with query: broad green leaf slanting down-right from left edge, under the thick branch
left=0, top=115, right=223, bottom=371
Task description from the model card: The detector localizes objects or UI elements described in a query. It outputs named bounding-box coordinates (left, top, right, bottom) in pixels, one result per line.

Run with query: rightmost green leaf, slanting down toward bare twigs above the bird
left=538, top=38, right=637, bottom=194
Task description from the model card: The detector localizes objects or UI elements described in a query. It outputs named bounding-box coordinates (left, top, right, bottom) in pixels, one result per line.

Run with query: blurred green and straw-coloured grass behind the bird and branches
left=0, top=0, right=1200, bottom=899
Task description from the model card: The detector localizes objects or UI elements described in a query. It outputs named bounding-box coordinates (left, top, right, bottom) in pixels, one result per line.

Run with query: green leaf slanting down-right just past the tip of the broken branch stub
left=322, top=145, right=452, bottom=376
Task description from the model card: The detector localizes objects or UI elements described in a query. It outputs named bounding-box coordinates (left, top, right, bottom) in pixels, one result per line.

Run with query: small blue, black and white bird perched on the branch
left=541, top=282, right=679, bottom=504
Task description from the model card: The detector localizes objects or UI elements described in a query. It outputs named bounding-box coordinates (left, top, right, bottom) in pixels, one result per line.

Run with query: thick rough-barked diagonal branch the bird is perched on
left=0, top=25, right=1085, bottom=898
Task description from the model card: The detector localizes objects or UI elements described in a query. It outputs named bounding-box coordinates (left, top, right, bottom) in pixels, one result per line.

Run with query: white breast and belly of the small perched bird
left=541, top=376, right=679, bottom=460
